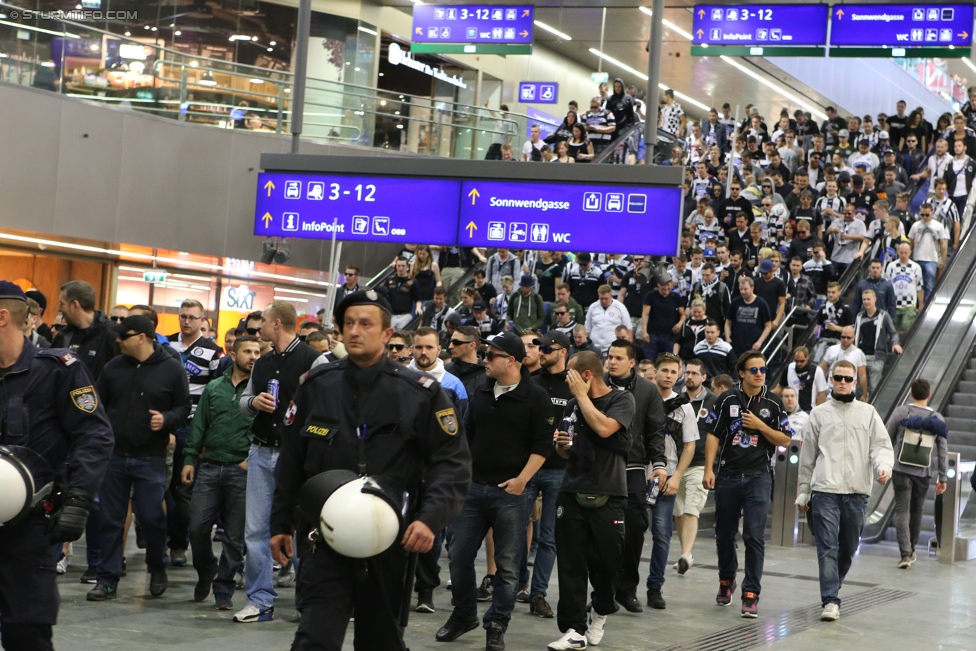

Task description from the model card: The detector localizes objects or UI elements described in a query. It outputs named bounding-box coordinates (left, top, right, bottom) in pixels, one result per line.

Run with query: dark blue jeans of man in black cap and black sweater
left=447, top=482, right=531, bottom=629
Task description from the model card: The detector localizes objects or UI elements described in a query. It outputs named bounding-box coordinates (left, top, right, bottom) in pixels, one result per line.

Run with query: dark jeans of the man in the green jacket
left=189, top=461, right=247, bottom=597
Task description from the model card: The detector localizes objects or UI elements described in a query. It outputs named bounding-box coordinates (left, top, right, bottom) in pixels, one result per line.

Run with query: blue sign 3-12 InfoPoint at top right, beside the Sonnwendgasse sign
left=691, top=4, right=828, bottom=47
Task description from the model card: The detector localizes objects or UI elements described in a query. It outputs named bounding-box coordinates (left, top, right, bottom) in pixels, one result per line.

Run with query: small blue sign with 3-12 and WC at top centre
left=411, top=4, right=535, bottom=45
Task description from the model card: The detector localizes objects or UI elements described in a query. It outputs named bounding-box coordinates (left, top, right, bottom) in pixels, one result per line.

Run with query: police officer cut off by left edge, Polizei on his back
left=0, top=281, right=113, bottom=651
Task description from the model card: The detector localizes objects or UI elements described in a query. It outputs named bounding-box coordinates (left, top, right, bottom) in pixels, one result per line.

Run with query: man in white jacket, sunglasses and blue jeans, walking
left=796, top=360, right=895, bottom=621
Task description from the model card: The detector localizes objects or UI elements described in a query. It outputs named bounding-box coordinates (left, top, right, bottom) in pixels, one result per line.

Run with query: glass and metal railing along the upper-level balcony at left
left=0, top=3, right=536, bottom=159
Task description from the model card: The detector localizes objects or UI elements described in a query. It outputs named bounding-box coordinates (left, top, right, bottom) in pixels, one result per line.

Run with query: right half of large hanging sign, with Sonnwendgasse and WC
left=458, top=181, right=681, bottom=255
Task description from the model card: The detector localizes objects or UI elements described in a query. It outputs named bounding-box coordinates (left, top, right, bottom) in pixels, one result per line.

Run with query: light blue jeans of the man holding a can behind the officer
left=244, top=444, right=278, bottom=610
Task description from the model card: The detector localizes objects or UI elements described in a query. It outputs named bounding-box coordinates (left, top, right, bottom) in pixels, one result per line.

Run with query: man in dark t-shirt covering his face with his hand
left=553, top=351, right=635, bottom=649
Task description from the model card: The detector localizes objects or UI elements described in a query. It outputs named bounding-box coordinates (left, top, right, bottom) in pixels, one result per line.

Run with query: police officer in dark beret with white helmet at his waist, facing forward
left=271, top=290, right=471, bottom=651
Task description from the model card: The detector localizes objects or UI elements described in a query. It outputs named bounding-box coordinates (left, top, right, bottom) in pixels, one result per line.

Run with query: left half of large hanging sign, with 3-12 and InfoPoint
left=254, top=172, right=461, bottom=245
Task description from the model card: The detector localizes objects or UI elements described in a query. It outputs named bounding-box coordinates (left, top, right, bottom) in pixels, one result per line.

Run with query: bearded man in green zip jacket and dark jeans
left=182, top=335, right=261, bottom=610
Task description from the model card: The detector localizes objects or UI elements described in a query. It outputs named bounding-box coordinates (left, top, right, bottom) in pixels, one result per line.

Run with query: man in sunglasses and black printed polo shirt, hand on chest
left=702, top=351, right=792, bottom=619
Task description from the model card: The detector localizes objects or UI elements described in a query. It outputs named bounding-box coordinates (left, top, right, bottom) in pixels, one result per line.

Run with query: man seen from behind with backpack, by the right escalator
left=886, top=378, right=949, bottom=570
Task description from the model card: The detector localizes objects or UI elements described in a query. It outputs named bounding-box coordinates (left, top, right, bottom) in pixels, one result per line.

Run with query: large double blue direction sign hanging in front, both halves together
left=254, top=161, right=682, bottom=255
